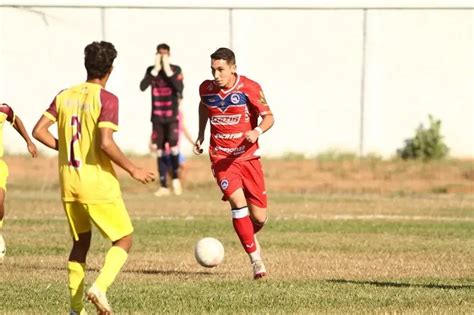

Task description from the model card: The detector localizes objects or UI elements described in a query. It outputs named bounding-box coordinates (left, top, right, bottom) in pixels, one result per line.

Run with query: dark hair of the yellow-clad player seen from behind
left=84, top=41, right=117, bottom=80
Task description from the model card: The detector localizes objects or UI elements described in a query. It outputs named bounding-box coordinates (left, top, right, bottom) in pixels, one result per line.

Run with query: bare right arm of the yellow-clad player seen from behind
left=99, top=128, right=155, bottom=184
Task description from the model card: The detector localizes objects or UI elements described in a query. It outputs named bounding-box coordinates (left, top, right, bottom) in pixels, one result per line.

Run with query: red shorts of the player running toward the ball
left=212, top=159, right=267, bottom=208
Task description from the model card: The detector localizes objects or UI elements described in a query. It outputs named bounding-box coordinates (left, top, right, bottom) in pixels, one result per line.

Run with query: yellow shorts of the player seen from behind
left=63, top=199, right=133, bottom=242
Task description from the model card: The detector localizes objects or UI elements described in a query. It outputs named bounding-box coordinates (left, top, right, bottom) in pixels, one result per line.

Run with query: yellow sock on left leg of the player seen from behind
left=67, top=261, right=86, bottom=314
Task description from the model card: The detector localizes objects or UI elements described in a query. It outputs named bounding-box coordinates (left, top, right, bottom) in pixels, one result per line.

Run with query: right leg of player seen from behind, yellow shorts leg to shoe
left=87, top=199, right=133, bottom=314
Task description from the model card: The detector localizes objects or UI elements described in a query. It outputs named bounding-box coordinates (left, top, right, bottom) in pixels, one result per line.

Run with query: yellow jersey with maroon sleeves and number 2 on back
left=44, top=82, right=121, bottom=203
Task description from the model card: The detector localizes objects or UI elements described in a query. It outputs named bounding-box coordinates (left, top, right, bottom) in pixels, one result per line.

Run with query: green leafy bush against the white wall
left=397, top=115, right=449, bottom=161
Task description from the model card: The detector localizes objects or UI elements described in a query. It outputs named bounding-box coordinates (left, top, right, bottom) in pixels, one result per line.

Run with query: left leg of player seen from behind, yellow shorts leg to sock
left=63, top=202, right=91, bottom=314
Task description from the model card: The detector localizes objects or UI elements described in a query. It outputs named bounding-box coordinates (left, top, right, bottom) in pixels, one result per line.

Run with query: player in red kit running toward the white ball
left=193, top=48, right=274, bottom=279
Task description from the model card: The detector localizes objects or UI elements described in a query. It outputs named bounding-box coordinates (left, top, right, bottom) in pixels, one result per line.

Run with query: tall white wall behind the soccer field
left=0, top=6, right=474, bottom=157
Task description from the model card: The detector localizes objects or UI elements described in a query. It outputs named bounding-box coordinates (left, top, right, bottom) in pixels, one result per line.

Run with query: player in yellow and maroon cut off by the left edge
left=0, top=103, right=38, bottom=263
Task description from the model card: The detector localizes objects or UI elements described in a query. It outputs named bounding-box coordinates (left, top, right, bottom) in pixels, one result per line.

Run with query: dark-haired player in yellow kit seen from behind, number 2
left=33, top=41, right=155, bottom=314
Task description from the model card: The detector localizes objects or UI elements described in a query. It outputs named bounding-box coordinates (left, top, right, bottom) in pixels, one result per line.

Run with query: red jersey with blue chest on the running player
left=199, top=75, right=271, bottom=162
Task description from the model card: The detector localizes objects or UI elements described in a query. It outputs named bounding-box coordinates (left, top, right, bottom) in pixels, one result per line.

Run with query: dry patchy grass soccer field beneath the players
left=0, top=156, right=474, bottom=314
